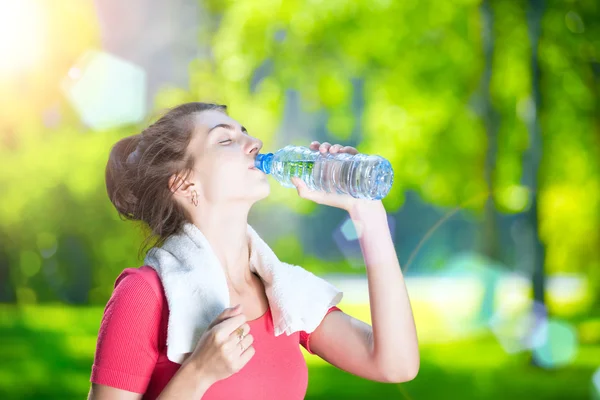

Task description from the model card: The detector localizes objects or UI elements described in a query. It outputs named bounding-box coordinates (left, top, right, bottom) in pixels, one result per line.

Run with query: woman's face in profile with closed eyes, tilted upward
left=188, top=110, right=270, bottom=205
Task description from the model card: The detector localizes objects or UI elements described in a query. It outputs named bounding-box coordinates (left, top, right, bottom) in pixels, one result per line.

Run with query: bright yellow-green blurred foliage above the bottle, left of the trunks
left=191, top=0, right=485, bottom=212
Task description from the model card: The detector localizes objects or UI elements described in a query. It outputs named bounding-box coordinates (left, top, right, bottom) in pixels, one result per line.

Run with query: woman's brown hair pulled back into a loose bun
left=106, top=102, right=227, bottom=258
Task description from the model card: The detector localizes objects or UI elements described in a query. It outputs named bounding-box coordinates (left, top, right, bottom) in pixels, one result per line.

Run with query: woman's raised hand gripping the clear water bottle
left=292, top=141, right=381, bottom=211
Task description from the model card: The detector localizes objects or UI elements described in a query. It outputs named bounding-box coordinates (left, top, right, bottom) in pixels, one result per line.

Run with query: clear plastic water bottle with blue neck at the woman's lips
left=254, top=145, right=394, bottom=200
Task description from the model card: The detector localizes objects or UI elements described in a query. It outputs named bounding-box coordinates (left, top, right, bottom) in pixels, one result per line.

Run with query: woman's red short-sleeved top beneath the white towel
left=90, top=266, right=341, bottom=400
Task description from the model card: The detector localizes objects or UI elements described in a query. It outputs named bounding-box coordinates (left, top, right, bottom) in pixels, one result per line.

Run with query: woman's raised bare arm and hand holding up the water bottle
left=292, top=142, right=420, bottom=382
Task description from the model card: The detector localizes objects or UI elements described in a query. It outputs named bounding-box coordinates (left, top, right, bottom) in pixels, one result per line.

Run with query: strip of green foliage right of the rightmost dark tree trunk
left=538, top=0, right=600, bottom=304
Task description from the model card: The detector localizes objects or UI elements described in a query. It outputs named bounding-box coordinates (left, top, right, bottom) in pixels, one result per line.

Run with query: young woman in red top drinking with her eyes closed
left=89, top=102, right=419, bottom=400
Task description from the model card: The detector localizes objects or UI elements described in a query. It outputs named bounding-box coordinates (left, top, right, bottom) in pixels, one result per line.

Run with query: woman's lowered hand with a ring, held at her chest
left=184, top=304, right=255, bottom=383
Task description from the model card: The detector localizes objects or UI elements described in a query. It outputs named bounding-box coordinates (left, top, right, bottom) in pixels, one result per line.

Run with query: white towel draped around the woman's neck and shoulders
left=144, top=223, right=343, bottom=364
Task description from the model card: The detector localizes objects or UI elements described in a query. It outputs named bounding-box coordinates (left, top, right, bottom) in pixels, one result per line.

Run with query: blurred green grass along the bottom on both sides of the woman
left=0, top=304, right=600, bottom=400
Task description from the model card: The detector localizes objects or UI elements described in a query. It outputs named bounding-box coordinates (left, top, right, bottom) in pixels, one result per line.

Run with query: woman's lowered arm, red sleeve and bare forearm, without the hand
left=88, top=271, right=218, bottom=400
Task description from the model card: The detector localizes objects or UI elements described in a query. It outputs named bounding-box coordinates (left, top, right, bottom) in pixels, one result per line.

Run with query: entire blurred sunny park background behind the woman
left=0, top=0, right=600, bottom=400
